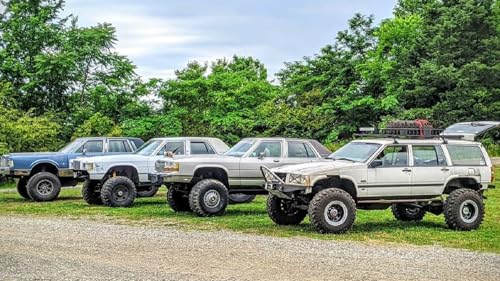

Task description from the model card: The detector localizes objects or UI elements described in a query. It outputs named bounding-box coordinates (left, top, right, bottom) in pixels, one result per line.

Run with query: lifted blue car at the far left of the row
left=0, top=137, right=144, bottom=201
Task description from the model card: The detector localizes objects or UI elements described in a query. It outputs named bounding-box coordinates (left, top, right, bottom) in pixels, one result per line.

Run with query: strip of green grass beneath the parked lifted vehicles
left=0, top=169, right=500, bottom=253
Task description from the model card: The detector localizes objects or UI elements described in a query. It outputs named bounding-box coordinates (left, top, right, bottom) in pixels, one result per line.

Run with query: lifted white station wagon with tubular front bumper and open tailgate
left=261, top=138, right=494, bottom=233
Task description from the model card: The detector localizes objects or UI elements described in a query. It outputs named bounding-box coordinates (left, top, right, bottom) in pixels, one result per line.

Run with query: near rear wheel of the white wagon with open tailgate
left=444, top=188, right=484, bottom=230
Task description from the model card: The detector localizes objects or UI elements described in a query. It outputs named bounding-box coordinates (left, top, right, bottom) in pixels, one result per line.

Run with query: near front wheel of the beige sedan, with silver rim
left=189, top=179, right=229, bottom=217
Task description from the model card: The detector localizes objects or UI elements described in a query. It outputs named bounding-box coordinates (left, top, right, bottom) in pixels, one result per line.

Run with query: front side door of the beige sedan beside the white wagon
left=240, top=140, right=283, bottom=186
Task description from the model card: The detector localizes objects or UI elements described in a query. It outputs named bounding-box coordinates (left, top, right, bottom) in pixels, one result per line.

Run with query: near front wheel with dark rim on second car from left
left=101, top=176, right=137, bottom=207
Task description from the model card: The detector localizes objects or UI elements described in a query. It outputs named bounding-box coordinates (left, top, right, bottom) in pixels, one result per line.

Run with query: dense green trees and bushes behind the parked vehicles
left=0, top=0, right=500, bottom=152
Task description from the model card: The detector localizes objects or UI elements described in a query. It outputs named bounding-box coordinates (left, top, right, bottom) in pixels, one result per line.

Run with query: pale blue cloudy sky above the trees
left=66, top=0, right=396, bottom=78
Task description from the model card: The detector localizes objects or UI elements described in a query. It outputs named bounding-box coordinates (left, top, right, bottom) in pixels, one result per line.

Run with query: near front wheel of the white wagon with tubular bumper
left=308, top=188, right=356, bottom=233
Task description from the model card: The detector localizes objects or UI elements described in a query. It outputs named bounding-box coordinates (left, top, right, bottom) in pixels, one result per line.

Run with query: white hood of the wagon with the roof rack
left=271, top=160, right=366, bottom=175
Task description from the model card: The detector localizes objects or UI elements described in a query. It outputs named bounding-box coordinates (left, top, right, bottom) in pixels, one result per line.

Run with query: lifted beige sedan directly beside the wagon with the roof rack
left=150, top=138, right=331, bottom=216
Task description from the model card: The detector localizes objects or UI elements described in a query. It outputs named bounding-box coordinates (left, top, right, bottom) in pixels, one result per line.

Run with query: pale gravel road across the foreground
left=0, top=217, right=500, bottom=281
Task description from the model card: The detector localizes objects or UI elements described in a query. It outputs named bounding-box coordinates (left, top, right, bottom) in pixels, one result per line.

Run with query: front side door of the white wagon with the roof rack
left=366, top=144, right=412, bottom=197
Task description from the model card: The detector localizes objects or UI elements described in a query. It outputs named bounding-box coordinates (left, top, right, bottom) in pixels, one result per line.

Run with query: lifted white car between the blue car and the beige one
left=71, top=137, right=229, bottom=207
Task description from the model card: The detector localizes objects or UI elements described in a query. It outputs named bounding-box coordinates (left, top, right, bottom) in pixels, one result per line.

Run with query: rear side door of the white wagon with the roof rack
left=411, top=145, right=451, bottom=195
